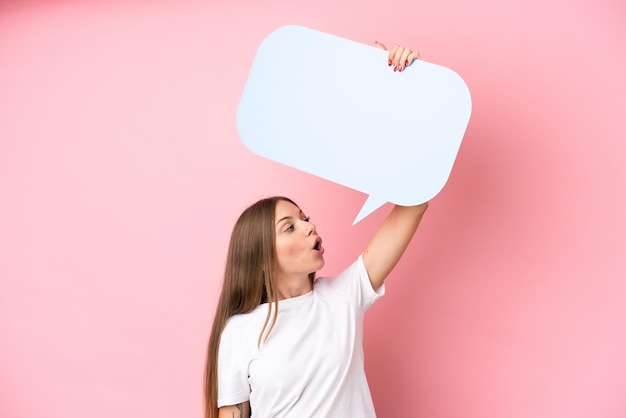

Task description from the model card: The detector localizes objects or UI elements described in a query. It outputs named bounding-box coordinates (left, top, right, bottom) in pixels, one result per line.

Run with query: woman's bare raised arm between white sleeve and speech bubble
left=363, top=202, right=428, bottom=290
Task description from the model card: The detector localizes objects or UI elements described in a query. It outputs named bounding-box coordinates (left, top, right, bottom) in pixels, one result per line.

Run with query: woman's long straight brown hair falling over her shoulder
left=204, top=196, right=315, bottom=418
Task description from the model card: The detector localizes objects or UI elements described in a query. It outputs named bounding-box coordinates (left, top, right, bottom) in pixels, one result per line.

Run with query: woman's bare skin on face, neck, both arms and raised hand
left=219, top=42, right=428, bottom=418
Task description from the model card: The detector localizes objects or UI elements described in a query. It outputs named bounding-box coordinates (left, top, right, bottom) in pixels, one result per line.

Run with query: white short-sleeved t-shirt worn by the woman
left=217, top=257, right=385, bottom=418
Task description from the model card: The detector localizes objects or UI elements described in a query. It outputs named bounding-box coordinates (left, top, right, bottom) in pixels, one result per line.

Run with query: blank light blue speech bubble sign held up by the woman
left=237, top=26, right=471, bottom=223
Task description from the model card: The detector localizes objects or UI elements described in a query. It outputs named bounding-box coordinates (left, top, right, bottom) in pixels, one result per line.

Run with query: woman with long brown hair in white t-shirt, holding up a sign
left=205, top=44, right=428, bottom=418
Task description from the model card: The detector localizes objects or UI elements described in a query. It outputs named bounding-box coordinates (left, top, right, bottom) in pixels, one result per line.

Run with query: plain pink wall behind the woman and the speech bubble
left=0, top=0, right=626, bottom=418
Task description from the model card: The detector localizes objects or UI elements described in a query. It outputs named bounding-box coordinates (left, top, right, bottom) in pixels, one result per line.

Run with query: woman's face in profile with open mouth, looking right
left=275, top=200, right=324, bottom=280
